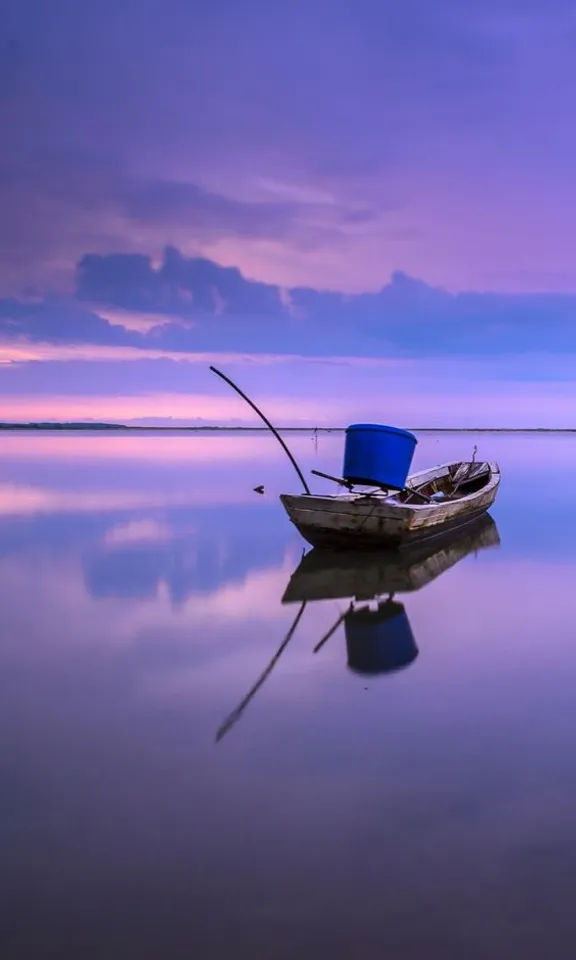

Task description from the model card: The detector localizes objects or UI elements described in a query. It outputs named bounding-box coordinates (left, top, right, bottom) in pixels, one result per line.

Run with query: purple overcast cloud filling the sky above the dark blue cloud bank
left=5, top=0, right=576, bottom=292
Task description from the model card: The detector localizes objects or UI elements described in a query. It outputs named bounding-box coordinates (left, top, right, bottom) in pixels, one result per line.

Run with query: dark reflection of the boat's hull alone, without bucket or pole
left=282, top=515, right=500, bottom=603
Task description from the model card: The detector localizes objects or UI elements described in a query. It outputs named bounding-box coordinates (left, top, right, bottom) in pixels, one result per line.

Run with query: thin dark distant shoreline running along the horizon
left=0, top=422, right=576, bottom=434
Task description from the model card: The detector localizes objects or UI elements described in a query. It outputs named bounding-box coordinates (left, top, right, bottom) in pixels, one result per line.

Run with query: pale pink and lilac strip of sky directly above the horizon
left=2, top=376, right=576, bottom=428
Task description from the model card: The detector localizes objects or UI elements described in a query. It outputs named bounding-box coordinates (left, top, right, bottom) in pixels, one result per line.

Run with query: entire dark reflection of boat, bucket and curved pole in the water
left=216, top=516, right=500, bottom=741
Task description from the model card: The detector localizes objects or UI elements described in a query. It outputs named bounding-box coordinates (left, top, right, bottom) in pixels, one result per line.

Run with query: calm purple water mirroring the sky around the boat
left=0, top=434, right=576, bottom=960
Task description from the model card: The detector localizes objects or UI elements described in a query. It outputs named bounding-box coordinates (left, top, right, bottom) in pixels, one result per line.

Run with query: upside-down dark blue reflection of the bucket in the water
left=344, top=600, right=418, bottom=675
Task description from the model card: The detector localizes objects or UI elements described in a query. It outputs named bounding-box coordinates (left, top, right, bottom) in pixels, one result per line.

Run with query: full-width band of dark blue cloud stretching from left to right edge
left=0, top=247, right=576, bottom=361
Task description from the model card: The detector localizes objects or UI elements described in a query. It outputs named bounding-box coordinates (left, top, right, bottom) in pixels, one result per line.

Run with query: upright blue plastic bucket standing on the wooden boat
left=343, top=423, right=418, bottom=489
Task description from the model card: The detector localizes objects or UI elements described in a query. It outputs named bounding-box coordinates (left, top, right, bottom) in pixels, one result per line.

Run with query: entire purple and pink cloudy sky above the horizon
left=0, top=0, right=576, bottom=426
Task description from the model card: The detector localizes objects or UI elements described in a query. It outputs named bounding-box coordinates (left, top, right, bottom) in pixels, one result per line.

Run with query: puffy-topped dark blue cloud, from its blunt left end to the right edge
left=72, top=247, right=576, bottom=355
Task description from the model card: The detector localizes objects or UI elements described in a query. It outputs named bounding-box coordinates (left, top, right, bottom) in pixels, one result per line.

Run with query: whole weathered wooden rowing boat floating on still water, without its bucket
left=280, top=461, right=500, bottom=549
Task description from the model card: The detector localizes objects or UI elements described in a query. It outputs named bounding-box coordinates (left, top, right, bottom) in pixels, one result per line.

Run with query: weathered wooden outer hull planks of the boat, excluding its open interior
left=280, top=463, right=500, bottom=549
